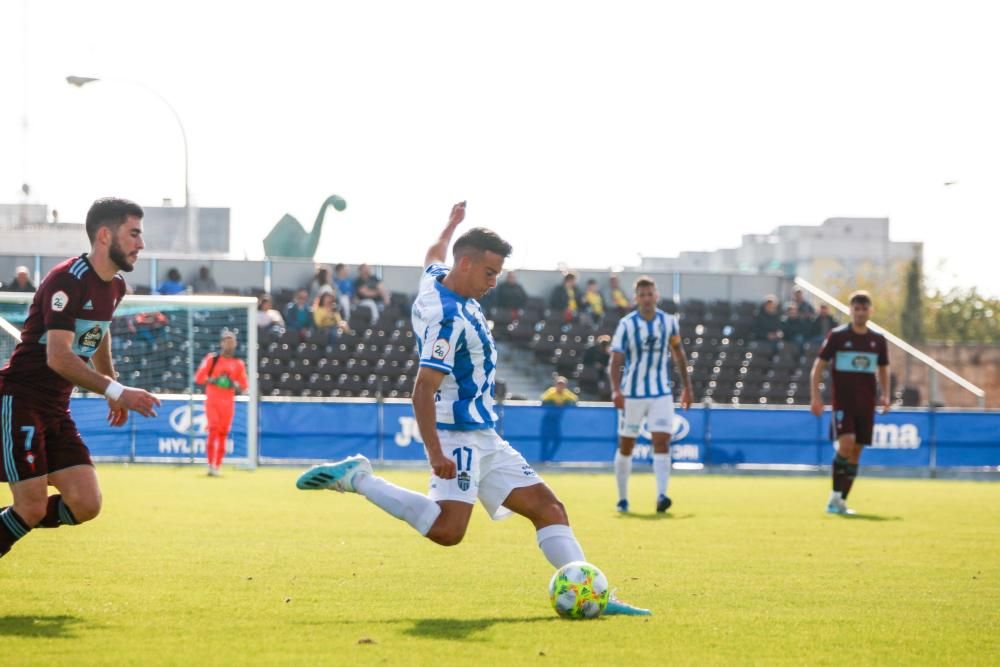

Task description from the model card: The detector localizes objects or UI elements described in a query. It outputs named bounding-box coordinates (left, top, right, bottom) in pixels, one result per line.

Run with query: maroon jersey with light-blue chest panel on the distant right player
left=819, top=324, right=889, bottom=415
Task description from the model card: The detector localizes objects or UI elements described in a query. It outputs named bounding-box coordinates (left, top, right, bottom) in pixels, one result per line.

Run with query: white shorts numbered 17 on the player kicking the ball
left=427, top=429, right=542, bottom=521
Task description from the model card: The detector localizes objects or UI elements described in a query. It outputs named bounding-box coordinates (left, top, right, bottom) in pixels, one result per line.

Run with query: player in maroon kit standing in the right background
left=811, top=291, right=889, bottom=514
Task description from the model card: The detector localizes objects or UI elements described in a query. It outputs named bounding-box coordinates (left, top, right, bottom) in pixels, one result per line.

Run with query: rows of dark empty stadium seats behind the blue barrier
left=103, top=290, right=836, bottom=405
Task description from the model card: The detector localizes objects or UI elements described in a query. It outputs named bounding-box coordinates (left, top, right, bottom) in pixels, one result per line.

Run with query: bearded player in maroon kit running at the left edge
left=0, top=198, right=160, bottom=556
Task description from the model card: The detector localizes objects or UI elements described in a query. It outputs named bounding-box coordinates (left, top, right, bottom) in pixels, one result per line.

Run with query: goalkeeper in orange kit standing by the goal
left=194, top=330, right=248, bottom=477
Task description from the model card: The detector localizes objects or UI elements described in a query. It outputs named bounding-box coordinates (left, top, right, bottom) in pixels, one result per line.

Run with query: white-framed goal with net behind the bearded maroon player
left=0, top=293, right=258, bottom=467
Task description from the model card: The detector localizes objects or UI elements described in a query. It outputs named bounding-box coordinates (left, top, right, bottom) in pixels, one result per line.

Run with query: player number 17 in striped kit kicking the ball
left=297, top=202, right=650, bottom=615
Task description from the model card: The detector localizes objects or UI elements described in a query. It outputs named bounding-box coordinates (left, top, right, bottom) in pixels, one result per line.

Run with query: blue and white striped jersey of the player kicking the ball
left=412, top=264, right=497, bottom=431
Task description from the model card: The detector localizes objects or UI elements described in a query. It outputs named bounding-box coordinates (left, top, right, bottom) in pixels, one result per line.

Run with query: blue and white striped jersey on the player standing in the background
left=611, top=308, right=680, bottom=398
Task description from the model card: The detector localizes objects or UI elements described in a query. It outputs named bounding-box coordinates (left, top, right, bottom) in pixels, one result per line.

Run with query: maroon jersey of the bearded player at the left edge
left=0, top=253, right=125, bottom=408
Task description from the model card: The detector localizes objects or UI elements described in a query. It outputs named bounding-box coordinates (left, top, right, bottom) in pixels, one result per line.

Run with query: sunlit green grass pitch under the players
left=0, top=465, right=1000, bottom=666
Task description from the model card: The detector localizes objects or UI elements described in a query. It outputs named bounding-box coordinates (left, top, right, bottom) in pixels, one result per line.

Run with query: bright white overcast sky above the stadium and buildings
left=0, top=0, right=1000, bottom=294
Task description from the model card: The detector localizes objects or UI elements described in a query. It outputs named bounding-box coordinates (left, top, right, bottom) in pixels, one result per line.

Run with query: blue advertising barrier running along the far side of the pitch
left=72, top=398, right=1000, bottom=468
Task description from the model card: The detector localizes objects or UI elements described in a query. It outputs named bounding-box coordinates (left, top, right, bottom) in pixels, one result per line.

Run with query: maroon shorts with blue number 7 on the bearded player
left=0, top=391, right=93, bottom=482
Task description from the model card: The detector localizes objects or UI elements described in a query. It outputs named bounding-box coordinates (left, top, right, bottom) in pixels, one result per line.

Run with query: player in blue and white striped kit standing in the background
left=608, top=276, right=692, bottom=512
